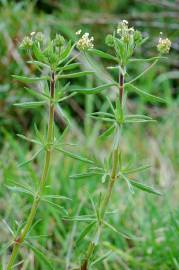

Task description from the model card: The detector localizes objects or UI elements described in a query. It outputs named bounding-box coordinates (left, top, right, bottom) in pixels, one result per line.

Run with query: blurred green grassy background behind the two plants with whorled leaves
left=0, top=0, right=179, bottom=270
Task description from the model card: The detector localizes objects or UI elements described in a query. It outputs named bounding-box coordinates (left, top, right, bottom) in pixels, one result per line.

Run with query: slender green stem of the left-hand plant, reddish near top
left=6, top=72, right=55, bottom=270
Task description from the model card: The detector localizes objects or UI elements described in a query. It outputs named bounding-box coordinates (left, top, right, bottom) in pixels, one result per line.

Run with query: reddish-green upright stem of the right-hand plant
left=80, top=70, right=124, bottom=270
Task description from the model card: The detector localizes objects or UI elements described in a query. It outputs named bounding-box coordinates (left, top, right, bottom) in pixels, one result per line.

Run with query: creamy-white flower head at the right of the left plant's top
left=76, top=30, right=94, bottom=51
